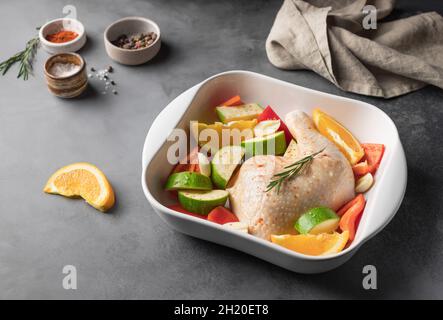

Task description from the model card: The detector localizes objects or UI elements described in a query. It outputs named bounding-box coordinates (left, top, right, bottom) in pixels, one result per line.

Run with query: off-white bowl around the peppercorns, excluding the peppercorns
left=104, top=17, right=161, bottom=65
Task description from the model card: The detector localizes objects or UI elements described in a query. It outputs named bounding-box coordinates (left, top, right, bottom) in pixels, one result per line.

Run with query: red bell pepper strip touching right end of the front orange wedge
left=337, top=194, right=366, bottom=241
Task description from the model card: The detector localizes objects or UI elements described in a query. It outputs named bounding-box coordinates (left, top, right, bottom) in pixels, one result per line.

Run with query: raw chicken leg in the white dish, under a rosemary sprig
left=228, top=111, right=355, bottom=240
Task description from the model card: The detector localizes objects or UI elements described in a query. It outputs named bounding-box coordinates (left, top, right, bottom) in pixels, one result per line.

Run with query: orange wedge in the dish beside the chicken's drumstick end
left=312, top=109, right=365, bottom=165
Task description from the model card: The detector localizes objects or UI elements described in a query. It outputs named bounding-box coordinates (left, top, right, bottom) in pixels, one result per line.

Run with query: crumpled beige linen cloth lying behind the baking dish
left=266, top=0, right=443, bottom=98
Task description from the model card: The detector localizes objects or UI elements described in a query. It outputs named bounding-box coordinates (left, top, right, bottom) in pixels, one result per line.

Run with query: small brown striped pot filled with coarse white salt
left=44, top=53, right=88, bottom=98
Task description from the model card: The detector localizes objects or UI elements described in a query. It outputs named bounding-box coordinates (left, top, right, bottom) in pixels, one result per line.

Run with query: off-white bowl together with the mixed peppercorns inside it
left=104, top=17, right=161, bottom=65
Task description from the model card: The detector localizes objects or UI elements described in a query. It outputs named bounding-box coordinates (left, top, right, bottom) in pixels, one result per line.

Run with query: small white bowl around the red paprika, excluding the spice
left=39, top=18, right=86, bottom=54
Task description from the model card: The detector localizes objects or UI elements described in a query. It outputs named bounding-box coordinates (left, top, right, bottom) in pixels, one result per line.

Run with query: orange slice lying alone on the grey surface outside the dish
left=43, top=162, right=115, bottom=212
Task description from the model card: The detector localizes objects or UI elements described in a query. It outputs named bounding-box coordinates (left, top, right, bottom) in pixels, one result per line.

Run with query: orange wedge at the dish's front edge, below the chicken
left=271, top=231, right=349, bottom=256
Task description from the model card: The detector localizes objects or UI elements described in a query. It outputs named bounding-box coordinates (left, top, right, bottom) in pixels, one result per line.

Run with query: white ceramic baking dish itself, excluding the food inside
left=141, top=71, right=407, bottom=273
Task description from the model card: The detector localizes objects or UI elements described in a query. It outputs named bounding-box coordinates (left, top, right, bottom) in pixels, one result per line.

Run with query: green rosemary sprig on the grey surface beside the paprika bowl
left=0, top=37, right=40, bottom=80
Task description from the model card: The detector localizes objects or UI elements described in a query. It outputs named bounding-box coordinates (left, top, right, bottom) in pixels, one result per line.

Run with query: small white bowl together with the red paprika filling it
left=39, top=18, right=86, bottom=54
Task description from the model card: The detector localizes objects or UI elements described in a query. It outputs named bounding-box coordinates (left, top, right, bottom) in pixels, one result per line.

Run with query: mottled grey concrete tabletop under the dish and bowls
left=0, top=0, right=443, bottom=299
